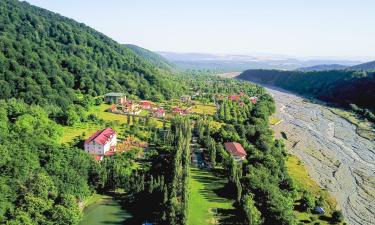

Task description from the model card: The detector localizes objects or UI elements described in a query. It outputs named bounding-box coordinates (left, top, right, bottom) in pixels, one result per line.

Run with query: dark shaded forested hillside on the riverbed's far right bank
left=237, top=70, right=375, bottom=121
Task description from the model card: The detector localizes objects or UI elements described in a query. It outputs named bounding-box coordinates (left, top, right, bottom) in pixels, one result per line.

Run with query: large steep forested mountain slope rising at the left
left=0, top=0, right=182, bottom=108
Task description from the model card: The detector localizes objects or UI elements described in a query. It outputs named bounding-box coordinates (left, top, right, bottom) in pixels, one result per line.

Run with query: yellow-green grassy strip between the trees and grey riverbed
left=286, top=155, right=337, bottom=224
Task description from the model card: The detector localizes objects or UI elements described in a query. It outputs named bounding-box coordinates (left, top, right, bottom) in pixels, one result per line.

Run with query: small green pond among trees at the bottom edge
left=79, top=196, right=132, bottom=225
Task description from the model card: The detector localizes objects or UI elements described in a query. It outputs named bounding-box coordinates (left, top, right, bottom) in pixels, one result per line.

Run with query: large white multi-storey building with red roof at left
left=84, top=128, right=117, bottom=156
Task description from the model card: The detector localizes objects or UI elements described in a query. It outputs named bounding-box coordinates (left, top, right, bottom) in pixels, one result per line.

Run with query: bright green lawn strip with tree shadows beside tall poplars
left=188, top=168, right=234, bottom=225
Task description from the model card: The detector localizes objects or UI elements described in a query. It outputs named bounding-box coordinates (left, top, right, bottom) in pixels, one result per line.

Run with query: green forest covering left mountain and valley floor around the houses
left=0, top=0, right=344, bottom=225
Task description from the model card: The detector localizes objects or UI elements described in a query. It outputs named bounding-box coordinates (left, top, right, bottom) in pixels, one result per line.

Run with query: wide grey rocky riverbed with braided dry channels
left=267, top=88, right=375, bottom=225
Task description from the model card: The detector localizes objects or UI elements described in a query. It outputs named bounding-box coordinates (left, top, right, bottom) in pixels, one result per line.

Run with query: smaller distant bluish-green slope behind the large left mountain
left=125, top=44, right=174, bottom=70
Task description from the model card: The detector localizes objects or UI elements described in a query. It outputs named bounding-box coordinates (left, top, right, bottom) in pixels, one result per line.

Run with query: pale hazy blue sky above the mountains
left=27, top=0, right=375, bottom=58
